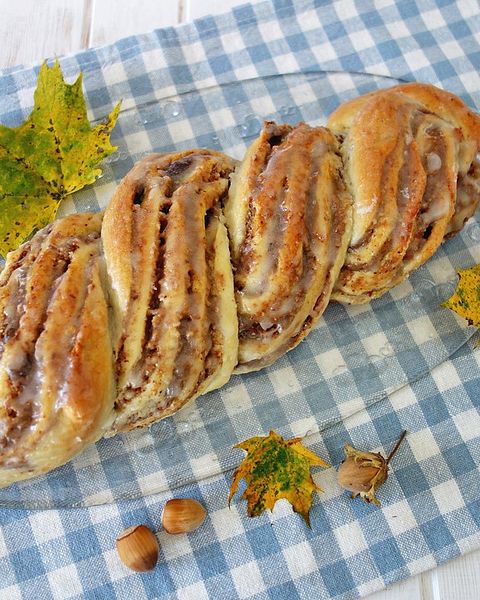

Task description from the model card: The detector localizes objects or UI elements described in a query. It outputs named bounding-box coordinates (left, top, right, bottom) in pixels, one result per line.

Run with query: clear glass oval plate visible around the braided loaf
left=0, top=71, right=480, bottom=509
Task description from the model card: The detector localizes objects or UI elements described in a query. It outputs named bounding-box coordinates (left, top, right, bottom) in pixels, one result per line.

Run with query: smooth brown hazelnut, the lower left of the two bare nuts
left=117, top=525, right=159, bottom=572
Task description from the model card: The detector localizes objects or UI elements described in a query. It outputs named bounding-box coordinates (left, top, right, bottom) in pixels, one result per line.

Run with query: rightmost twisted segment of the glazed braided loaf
left=328, top=83, right=480, bottom=303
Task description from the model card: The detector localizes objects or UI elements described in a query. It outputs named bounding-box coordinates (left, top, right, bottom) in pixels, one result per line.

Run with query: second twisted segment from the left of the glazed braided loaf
left=102, top=150, right=238, bottom=433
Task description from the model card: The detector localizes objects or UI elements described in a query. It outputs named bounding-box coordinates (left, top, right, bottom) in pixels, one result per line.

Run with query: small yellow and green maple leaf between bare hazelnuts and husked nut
left=228, top=431, right=329, bottom=527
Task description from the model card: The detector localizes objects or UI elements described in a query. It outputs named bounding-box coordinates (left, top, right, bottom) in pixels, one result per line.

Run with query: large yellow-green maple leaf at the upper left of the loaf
left=0, top=61, right=120, bottom=256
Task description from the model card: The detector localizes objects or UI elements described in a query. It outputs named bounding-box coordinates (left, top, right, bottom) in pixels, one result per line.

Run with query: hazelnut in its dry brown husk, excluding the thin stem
left=337, top=444, right=388, bottom=505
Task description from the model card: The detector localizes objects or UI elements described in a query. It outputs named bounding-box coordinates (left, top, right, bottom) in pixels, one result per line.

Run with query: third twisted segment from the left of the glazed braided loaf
left=225, top=122, right=352, bottom=372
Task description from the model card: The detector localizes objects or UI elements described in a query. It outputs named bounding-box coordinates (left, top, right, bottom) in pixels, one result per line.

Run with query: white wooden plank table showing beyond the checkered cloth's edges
left=0, top=0, right=480, bottom=600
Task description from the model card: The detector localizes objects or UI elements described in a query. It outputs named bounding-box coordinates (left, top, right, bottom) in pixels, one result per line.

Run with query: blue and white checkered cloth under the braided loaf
left=0, top=0, right=480, bottom=600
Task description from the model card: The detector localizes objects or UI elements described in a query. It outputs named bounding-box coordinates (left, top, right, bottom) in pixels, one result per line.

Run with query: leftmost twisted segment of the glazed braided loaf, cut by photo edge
left=0, top=214, right=115, bottom=487
